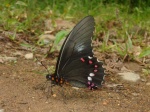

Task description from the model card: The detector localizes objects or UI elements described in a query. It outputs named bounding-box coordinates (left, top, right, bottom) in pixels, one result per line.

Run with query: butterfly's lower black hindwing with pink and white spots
left=62, top=57, right=104, bottom=87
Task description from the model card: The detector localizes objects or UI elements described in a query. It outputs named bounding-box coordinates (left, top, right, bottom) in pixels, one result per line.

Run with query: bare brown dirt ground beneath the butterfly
left=0, top=40, right=150, bottom=112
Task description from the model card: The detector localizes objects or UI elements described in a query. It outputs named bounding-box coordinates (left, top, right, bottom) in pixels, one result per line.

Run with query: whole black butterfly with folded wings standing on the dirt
left=46, top=16, right=105, bottom=90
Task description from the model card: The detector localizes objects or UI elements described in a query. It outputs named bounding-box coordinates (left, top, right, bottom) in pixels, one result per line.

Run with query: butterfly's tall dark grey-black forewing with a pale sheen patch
left=55, top=16, right=95, bottom=77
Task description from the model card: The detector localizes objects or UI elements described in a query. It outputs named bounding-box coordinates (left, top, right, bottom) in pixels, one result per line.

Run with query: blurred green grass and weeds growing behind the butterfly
left=0, top=0, right=150, bottom=62
